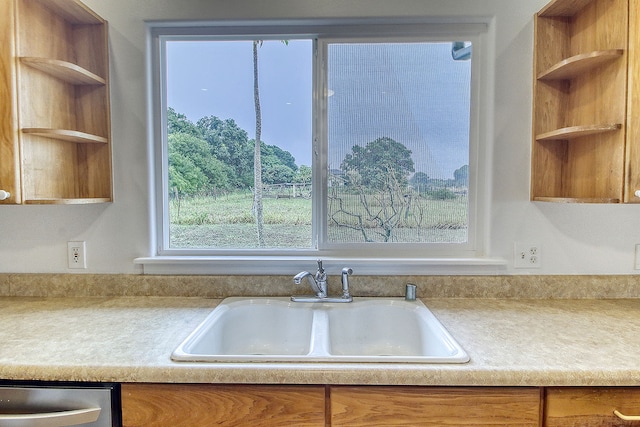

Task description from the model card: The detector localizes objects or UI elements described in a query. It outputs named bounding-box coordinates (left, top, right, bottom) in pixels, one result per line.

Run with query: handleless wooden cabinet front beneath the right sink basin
left=330, top=386, right=540, bottom=427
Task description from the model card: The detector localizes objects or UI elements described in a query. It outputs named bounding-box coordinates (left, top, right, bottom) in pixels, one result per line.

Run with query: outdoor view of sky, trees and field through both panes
left=166, top=40, right=471, bottom=249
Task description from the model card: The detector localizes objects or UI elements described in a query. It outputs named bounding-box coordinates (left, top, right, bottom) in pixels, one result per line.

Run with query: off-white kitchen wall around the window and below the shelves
left=0, top=0, right=640, bottom=274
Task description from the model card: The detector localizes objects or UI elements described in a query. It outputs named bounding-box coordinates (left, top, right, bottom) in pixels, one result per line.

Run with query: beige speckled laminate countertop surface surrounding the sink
left=0, top=297, right=640, bottom=386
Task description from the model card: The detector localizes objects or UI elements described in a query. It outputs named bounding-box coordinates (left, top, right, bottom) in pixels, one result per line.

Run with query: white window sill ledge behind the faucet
left=134, top=256, right=507, bottom=276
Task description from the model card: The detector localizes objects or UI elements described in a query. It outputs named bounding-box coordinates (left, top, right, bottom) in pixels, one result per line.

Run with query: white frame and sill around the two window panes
left=135, top=18, right=506, bottom=275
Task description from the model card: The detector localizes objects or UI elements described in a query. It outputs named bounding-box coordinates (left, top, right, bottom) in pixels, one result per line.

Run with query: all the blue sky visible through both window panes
left=167, top=40, right=471, bottom=178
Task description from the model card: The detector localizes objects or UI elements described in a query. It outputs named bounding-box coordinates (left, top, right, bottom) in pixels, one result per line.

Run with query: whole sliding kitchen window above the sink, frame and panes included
left=141, top=21, right=498, bottom=272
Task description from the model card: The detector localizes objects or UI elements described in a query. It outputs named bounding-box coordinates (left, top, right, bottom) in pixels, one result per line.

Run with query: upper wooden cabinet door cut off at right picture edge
left=625, top=0, right=640, bottom=203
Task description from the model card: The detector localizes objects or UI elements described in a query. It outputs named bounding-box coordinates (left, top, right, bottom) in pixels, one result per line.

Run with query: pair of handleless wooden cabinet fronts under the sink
left=122, top=384, right=541, bottom=427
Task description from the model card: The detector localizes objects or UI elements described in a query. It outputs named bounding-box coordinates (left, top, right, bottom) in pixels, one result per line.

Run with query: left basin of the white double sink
left=171, top=298, right=313, bottom=362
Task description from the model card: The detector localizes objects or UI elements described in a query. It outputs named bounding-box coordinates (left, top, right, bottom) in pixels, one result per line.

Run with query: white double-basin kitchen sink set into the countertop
left=171, top=298, right=469, bottom=363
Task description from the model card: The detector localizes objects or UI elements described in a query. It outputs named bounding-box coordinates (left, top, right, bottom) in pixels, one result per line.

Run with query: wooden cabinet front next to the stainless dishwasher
left=122, top=384, right=325, bottom=427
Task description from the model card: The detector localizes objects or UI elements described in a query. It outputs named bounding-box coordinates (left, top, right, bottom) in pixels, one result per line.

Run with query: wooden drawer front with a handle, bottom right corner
left=544, top=387, right=640, bottom=427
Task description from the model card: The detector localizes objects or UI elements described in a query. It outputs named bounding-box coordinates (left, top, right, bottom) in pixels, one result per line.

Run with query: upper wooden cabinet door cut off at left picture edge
left=0, top=1, right=21, bottom=204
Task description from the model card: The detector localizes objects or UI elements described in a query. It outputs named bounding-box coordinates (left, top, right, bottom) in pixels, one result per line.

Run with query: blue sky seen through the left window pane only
left=167, top=40, right=312, bottom=165
